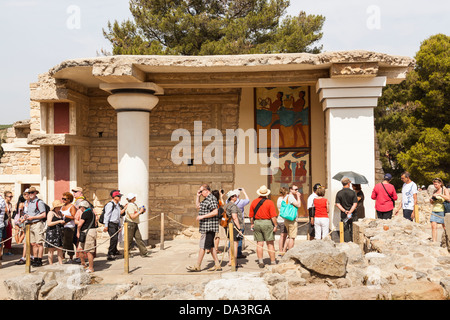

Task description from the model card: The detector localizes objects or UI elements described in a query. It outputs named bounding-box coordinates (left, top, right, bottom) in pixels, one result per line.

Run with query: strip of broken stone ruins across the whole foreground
left=4, top=212, right=450, bottom=300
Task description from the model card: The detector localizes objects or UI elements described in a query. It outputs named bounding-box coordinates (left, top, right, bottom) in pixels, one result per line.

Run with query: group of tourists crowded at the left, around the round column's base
left=0, top=187, right=148, bottom=273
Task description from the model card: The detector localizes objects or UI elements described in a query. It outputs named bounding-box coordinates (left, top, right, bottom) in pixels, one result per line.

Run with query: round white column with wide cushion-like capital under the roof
left=100, top=83, right=162, bottom=242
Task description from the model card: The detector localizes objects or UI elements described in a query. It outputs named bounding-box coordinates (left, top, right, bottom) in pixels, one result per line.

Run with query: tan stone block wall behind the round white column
left=81, top=89, right=240, bottom=239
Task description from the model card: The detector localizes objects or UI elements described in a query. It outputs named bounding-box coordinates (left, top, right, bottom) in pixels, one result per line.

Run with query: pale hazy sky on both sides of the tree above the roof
left=0, top=0, right=450, bottom=124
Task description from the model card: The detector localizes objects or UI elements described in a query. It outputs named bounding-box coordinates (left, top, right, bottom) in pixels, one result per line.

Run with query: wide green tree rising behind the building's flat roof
left=103, top=0, right=325, bottom=55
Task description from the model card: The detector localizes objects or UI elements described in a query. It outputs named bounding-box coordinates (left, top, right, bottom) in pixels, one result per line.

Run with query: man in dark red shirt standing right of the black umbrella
left=372, top=173, right=397, bottom=219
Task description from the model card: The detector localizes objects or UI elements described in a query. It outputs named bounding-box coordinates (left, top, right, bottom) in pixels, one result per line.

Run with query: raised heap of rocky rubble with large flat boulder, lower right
left=263, top=216, right=450, bottom=300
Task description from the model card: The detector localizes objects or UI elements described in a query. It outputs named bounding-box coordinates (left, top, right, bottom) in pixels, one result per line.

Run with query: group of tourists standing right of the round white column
left=187, top=172, right=450, bottom=272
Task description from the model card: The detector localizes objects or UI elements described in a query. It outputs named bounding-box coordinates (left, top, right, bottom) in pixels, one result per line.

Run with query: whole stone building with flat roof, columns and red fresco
left=0, top=51, right=415, bottom=238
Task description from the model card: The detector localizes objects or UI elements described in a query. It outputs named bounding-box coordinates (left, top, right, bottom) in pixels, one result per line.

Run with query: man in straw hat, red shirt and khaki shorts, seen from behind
left=249, top=186, right=277, bottom=268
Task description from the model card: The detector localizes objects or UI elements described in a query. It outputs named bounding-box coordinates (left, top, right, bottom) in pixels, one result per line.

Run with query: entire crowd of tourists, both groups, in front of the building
left=0, top=172, right=450, bottom=272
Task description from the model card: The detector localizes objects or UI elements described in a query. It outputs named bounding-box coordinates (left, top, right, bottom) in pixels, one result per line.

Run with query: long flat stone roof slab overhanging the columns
left=49, top=50, right=415, bottom=88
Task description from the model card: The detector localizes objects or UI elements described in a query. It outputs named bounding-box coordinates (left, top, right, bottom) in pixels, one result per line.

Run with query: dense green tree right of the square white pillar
left=375, top=34, right=450, bottom=187
